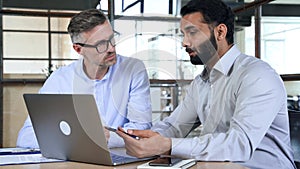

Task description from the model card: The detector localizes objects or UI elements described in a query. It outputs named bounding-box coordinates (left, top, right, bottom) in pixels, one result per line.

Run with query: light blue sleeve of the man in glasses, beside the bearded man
left=108, top=58, right=152, bottom=147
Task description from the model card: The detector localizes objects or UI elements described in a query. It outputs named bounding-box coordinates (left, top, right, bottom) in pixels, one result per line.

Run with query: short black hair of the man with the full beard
left=180, top=0, right=234, bottom=44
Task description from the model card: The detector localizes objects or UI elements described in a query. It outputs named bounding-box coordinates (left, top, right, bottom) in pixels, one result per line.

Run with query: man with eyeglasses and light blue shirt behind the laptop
left=17, top=9, right=152, bottom=148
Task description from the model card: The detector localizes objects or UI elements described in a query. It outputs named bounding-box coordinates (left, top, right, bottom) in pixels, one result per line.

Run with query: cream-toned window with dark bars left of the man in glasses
left=2, top=9, right=78, bottom=81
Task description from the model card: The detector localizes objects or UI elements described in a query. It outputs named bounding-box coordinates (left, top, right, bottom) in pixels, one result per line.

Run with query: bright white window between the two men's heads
left=114, top=17, right=203, bottom=79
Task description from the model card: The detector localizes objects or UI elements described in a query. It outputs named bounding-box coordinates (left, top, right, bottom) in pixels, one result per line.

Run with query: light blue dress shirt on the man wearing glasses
left=17, top=55, right=152, bottom=148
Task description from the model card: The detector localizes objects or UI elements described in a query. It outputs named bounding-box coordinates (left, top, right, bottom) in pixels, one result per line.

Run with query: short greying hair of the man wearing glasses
left=68, top=9, right=108, bottom=43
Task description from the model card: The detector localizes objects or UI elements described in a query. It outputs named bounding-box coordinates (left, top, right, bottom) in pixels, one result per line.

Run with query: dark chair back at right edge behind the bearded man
left=289, top=110, right=300, bottom=169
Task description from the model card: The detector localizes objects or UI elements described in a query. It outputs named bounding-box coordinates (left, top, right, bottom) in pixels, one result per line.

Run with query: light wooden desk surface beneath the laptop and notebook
left=1, top=162, right=247, bottom=169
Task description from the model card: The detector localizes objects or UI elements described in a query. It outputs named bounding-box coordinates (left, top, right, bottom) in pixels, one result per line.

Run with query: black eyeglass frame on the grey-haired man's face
left=74, top=30, right=121, bottom=54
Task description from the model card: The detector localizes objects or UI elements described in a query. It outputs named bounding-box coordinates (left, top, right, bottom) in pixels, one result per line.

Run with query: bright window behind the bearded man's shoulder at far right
left=245, top=17, right=300, bottom=74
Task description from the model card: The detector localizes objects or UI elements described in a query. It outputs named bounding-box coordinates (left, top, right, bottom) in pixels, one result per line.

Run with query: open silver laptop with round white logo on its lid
left=23, top=94, right=152, bottom=165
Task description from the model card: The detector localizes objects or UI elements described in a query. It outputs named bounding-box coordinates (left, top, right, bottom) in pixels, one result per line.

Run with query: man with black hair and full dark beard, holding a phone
left=118, top=0, right=296, bottom=169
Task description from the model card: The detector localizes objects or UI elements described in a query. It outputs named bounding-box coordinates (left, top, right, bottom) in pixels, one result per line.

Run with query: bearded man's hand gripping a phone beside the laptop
left=117, top=127, right=171, bottom=158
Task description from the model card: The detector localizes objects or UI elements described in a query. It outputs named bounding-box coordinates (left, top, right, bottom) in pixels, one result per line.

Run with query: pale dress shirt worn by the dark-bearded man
left=152, top=46, right=295, bottom=169
